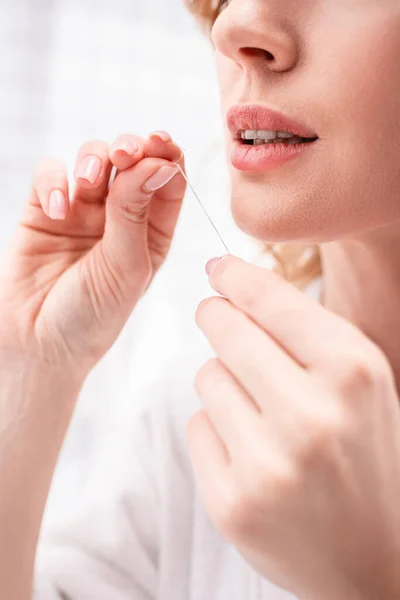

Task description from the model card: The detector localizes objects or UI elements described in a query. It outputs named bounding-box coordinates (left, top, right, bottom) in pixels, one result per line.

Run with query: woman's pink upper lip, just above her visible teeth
left=227, top=104, right=318, bottom=138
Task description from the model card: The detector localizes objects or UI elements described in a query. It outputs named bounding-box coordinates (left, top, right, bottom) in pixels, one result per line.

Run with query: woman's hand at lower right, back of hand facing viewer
left=187, top=255, right=400, bottom=600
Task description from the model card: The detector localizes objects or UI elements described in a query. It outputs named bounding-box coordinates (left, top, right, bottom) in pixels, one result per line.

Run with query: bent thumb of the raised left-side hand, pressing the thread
left=102, top=157, right=185, bottom=275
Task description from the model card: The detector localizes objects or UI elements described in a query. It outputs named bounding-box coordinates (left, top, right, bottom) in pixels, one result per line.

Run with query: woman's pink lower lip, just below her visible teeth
left=231, top=140, right=316, bottom=173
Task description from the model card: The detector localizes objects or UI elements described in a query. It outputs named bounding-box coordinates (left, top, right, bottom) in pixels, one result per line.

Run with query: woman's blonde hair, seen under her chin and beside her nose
left=185, top=0, right=322, bottom=289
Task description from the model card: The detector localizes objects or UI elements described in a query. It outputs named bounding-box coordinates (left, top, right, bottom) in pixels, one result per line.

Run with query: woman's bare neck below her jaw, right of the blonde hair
left=321, top=232, right=400, bottom=390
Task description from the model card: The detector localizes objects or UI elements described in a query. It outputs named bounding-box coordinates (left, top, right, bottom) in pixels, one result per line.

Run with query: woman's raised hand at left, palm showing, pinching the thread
left=0, top=132, right=186, bottom=373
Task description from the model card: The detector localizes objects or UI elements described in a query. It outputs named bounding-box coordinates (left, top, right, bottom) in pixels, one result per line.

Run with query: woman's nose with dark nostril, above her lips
left=211, top=0, right=299, bottom=72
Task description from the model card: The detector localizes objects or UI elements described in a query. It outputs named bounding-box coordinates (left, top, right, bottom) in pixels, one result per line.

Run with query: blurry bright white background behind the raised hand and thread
left=0, top=0, right=266, bottom=516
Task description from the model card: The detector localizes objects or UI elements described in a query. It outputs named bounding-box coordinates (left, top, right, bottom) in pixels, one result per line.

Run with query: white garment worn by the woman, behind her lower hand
left=34, top=280, right=319, bottom=600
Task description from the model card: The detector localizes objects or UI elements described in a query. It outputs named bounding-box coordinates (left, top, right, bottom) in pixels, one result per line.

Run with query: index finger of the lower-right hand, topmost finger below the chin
left=210, top=255, right=372, bottom=368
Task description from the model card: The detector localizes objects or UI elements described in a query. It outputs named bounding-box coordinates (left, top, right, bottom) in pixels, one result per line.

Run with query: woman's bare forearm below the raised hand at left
left=0, top=352, right=82, bottom=598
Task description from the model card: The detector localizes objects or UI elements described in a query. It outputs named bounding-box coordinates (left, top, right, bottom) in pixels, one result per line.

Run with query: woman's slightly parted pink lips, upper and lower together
left=227, top=104, right=318, bottom=173
